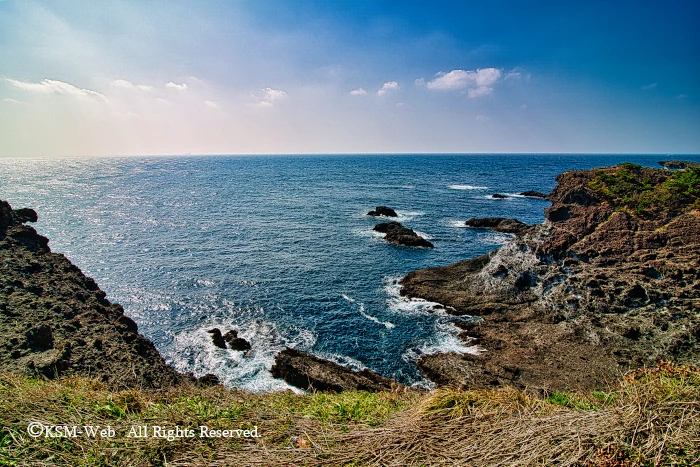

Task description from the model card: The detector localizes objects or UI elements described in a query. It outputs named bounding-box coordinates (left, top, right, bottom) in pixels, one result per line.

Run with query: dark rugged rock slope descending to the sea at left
left=0, top=201, right=189, bottom=387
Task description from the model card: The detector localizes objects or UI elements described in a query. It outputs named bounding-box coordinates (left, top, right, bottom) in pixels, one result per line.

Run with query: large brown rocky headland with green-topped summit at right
left=401, top=164, right=700, bottom=390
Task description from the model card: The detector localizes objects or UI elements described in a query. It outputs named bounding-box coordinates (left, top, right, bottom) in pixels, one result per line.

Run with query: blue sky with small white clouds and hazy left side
left=0, top=0, right=700, bottom=157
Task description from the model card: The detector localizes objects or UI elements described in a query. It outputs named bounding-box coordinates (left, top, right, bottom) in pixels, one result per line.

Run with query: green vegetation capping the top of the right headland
left=588, top=162, right=700, bottom=217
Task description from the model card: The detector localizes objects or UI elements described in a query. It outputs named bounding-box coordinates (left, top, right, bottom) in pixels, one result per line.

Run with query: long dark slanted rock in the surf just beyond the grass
left=270, top=348, right=395, bottom=392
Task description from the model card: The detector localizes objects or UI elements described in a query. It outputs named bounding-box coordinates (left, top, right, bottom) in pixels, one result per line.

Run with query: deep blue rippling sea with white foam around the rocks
left=0, top=154, right=700, bottom=391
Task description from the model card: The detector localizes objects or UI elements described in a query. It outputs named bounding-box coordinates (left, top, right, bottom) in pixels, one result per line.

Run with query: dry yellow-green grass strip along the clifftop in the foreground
left=0, top=363, right=700, bottom=466
